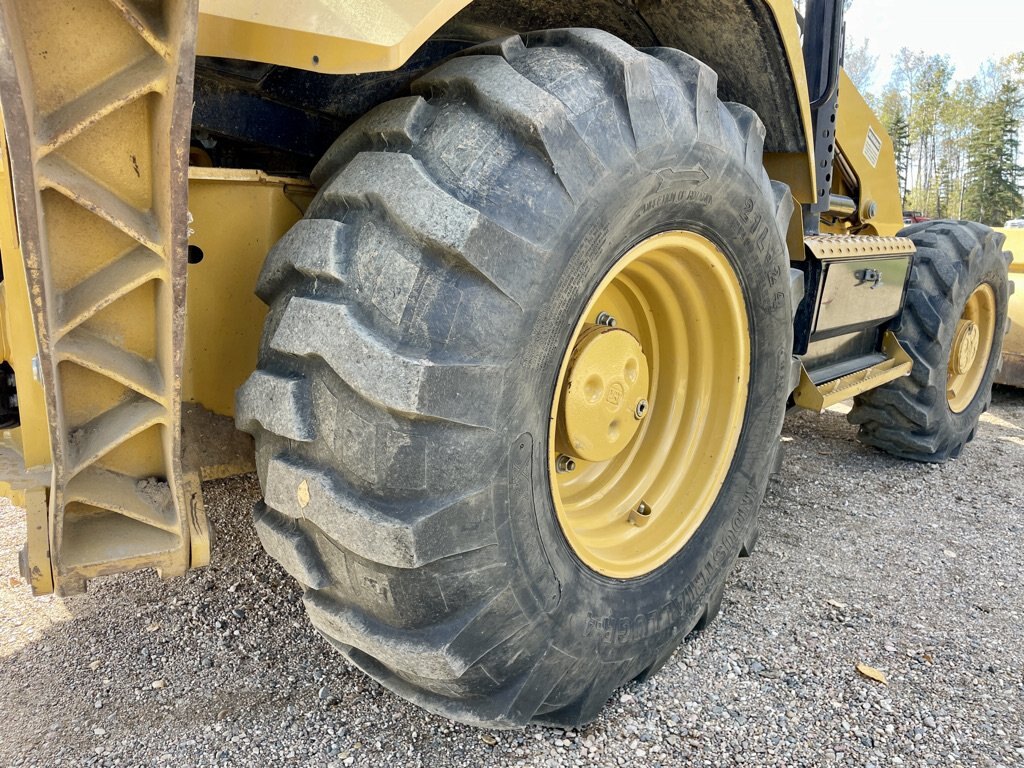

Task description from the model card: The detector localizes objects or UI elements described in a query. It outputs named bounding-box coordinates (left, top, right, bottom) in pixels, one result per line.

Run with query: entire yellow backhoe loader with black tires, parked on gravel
left=0, top=0, right=1009, bottom=727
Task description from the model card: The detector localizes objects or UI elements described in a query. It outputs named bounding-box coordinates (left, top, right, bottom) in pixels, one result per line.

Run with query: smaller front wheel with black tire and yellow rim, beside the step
left=847, top=220, right=1010, bottom=463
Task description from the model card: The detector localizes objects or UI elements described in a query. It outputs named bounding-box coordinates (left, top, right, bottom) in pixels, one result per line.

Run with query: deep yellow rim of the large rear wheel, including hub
left=548, top=231, right=751, bottom=579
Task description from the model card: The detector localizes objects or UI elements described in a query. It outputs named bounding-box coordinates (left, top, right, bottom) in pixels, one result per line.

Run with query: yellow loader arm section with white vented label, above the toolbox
left=836, top=71, right=903, bottom=237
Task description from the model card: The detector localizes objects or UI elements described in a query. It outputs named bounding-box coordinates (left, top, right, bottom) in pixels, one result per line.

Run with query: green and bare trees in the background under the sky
left=840, top=41, right=1024, bottom=226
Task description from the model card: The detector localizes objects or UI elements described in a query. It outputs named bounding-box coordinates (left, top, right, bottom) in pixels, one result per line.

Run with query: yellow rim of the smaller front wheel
left=946, top=283, right=995, bottom=414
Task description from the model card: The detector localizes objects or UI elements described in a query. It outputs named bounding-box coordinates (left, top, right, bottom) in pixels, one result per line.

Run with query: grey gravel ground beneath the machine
left=0, top=389, right=1024, bottom=768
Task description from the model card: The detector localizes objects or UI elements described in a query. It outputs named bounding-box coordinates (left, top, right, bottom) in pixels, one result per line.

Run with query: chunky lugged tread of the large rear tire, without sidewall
left=238, top=30, right=793, bottom=727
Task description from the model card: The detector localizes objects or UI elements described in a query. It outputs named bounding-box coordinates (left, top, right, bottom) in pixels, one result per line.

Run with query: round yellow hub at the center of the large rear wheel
left=559, top=325, right=650, bottom=462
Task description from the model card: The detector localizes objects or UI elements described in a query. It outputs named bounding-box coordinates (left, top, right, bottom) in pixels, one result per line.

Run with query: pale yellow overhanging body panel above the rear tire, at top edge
left=197, top=0, right=470, bottom=75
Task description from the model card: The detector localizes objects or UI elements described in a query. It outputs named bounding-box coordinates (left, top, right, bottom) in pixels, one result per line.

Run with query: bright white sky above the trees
left=846, top=0, right=1024, bottom=90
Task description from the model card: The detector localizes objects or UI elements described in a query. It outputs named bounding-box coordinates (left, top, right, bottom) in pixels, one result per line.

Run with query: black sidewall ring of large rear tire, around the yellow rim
left=498, top=144, right=793, bottom=667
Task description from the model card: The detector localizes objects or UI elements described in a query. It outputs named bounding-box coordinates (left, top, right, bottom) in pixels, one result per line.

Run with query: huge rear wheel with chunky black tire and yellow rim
left=238, top=30, right=793, bottom=727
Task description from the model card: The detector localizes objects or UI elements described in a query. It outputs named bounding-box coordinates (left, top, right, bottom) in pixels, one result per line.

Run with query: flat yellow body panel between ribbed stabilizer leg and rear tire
left=181, top=168, right=311, bottom=416
